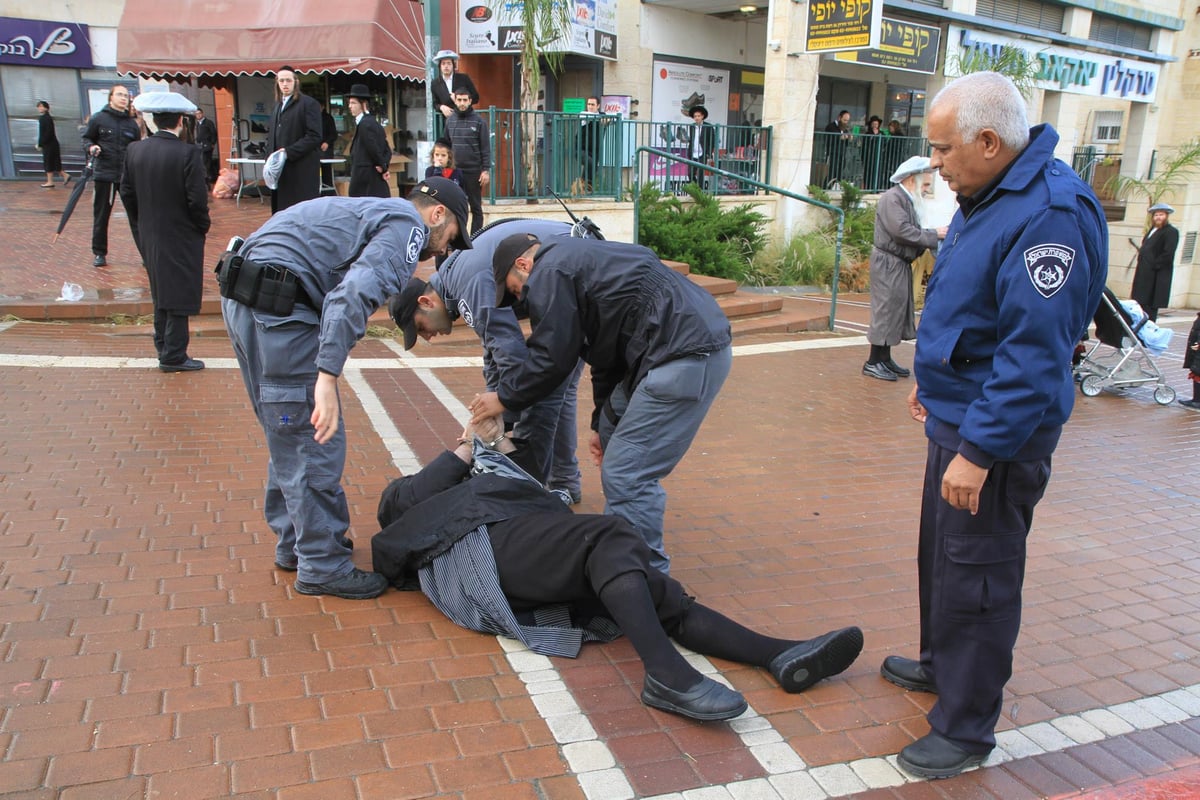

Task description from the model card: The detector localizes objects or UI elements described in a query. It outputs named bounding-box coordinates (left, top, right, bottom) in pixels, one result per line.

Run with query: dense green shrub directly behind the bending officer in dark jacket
left=637, top=184, right=767, bottom=283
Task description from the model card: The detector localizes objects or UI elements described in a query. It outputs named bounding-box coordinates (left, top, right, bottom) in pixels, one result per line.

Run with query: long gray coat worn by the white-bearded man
left=866, top=185, right=937, bottom=347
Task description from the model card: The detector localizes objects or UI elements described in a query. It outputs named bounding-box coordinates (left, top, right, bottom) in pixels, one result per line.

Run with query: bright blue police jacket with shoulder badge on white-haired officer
left=914, top=125, right=1109, bottom=468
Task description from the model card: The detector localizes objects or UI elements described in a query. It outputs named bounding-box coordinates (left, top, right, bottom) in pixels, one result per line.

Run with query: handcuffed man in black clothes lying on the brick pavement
left=371, top=438, right=863, bottom=720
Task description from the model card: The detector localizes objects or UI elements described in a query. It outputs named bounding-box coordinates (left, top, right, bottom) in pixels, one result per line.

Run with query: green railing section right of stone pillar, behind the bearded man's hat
left=810, top=131, right=929, bottom=193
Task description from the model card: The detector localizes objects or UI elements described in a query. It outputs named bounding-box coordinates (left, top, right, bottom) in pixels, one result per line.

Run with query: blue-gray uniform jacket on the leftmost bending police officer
left=240, top=197, right=428, bottom=375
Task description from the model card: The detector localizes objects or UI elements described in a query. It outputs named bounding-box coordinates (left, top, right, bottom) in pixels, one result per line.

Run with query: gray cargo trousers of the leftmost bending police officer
left=221, top=297, right=354, bottom=583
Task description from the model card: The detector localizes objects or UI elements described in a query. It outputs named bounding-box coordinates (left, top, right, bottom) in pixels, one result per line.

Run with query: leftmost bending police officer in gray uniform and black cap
left=217, top=178, right=470, bottom=600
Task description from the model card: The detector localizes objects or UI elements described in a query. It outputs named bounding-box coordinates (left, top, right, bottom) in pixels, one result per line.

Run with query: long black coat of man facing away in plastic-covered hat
left=121, top=131, right=210, bottom=315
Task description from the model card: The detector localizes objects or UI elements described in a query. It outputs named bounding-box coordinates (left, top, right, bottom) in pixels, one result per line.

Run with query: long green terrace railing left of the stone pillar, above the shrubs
left=434, top=106, right=772, bottom=203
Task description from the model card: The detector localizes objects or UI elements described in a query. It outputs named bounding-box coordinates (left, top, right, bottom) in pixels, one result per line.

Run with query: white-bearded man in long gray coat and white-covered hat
left=863, top=156, right=946, bottom=381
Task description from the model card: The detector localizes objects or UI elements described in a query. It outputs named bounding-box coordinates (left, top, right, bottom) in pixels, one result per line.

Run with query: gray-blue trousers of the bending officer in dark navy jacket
left=600, top=347, right=733, bottom=572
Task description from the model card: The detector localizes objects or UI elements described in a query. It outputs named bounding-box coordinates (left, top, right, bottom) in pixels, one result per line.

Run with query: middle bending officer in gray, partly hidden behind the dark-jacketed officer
left=390, top=219, right=594, bottom=504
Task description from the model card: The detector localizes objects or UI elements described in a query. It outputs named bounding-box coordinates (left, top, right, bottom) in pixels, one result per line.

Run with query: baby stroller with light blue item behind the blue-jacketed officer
left=1074, top=288, right=1175, bottom=405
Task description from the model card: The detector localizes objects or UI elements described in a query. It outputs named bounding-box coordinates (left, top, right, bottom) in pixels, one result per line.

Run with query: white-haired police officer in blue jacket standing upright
left=881, top=72, right=1108, bottom=778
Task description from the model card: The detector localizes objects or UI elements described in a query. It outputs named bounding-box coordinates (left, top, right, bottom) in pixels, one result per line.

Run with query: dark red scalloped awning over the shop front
left=116, top=0, right=427, bottom=80
